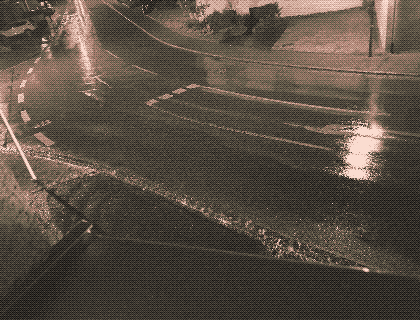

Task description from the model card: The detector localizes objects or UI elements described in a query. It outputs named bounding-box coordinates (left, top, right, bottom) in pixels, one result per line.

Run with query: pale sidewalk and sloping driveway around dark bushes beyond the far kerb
left=145, top=5, right=420, bottom=77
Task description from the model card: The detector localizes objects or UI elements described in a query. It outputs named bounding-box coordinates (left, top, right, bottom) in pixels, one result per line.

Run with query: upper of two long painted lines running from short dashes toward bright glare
left=200, top=86, right=390, bottom=117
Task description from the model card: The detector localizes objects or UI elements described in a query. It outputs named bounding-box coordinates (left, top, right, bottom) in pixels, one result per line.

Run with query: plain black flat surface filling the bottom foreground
left=7, top=234, right=419, bottom=319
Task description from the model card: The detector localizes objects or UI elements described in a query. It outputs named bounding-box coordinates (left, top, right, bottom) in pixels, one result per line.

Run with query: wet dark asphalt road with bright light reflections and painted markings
left=2, top=0, right=420, bottom=276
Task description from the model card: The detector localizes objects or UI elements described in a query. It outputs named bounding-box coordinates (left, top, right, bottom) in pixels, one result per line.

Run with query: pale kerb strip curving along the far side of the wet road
left=138, top=5, right=420, bottom=77
